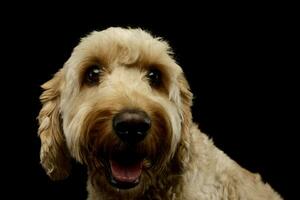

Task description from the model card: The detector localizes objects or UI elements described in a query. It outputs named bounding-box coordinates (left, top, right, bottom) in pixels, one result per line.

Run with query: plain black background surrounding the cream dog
left=1, top=4, right=299, bottom=199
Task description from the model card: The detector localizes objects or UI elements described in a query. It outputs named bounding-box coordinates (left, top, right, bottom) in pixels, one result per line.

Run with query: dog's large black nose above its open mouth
left=113, top=110, right=151, bottom=144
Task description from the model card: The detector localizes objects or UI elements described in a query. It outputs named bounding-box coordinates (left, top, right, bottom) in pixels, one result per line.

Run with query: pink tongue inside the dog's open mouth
left=110, top=160, right=143, bottom=182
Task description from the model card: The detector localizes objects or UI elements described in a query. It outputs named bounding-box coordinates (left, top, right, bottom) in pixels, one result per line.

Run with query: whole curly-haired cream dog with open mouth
left=38, top=28, right=281, bottom=200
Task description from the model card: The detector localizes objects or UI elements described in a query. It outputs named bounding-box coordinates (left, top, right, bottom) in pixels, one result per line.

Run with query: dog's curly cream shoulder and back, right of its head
left=185, top=125, right=281, bottom=200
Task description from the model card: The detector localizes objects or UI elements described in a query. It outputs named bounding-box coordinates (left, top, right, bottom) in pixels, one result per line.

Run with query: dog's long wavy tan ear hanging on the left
left=38, top=70, right=71, bottom=180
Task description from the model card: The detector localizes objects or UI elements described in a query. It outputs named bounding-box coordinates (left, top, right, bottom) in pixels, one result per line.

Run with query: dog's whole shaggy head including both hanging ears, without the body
left=39, top=28, right=192, bottom=195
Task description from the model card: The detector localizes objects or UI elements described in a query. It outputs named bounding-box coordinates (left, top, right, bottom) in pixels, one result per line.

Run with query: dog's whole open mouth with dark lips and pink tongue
left=107, top=148, right=144, bottom=189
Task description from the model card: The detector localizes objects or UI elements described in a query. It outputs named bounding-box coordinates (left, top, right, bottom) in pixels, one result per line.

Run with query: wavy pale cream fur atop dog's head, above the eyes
left=75, top=28, right=173, bottom=65
